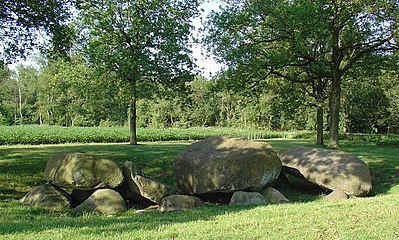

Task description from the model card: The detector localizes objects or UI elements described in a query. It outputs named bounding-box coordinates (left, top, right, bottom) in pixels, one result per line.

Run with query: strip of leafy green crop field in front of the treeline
left=0, top=125, right=315, bottom=145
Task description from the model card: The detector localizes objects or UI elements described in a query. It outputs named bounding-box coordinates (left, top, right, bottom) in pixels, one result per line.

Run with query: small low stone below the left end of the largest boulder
left=159, top=195, right=204, bottom=212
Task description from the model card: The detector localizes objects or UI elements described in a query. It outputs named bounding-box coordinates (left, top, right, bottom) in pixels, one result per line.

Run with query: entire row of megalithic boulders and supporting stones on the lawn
left=21, top=137, right=371, bottom=214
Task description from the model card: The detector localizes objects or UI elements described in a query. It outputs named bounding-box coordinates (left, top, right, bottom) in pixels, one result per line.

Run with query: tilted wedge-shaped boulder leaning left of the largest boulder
left=122, top=161, right=178, bottom=204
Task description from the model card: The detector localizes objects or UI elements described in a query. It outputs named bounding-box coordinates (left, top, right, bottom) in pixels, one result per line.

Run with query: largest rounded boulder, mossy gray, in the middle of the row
left=174, top=137, right=282, bottom=195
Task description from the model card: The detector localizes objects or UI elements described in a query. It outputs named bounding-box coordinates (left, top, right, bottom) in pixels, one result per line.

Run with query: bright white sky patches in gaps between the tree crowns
left=9, top=0, right=222, bottom=78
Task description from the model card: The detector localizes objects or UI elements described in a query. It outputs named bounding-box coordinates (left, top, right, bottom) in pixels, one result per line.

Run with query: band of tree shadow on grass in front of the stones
left=0, top=201, right=267, bottom=235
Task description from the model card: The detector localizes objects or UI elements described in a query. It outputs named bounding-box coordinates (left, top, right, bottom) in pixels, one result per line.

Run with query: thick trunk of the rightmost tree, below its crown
left=328, top=73, right=341, bottom=148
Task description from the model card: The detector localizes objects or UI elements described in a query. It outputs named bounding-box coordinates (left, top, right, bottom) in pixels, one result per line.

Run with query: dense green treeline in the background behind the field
left=0, top=57, right=399, bottom=133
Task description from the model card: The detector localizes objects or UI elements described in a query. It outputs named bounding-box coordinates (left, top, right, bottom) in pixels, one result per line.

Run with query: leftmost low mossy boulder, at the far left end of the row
left=20, top=183, right=71, bottom=211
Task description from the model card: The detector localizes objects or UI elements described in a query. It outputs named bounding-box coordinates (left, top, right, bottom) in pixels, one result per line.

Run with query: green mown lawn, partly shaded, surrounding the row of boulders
left=0, top=139, right=399, bottom=240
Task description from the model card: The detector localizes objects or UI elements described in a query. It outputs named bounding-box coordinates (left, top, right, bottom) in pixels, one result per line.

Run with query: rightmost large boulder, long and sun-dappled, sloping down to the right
left=278, top=147, right=372, bottom=196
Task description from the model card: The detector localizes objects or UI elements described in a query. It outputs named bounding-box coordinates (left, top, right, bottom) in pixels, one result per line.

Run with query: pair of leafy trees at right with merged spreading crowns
left=205, top=0, right=399, bottom=147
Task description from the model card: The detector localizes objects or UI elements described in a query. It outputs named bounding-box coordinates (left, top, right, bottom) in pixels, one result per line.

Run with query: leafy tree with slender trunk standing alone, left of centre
left=79, top=0, right=199, bottom=144
